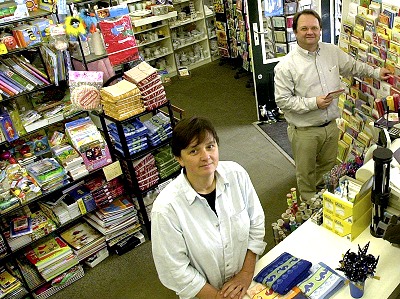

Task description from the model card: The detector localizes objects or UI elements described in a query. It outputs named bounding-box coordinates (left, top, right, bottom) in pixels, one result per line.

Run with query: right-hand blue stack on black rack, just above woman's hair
left=143, top=112, right=172, bottom=146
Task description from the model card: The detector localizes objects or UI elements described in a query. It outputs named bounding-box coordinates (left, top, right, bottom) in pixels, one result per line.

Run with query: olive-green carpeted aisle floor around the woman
left=51, top=61, right=295, bottom=299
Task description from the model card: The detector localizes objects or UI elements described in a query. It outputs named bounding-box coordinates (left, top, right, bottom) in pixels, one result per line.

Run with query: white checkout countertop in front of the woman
left=244, top=220, right=400, bottom=299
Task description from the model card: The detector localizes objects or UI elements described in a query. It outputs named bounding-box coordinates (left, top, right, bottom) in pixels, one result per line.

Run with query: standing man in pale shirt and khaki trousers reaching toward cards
left=274, top=9, right=390, bottom=200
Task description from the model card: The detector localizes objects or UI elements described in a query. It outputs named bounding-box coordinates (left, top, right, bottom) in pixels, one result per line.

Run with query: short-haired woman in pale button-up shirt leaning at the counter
left=151, top=117, right=266, bottom=299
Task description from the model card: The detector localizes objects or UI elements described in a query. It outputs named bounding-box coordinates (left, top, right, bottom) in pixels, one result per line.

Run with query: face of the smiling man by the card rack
left=294, top=14, right=321, bottom=52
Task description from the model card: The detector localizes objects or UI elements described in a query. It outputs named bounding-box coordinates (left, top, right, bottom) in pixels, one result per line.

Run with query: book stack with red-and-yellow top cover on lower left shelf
left=25, top=236, right=78, bottom=281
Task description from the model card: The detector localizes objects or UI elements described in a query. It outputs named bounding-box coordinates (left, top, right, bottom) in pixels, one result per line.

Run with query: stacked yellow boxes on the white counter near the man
left=322, top=178, right=372, bottom=241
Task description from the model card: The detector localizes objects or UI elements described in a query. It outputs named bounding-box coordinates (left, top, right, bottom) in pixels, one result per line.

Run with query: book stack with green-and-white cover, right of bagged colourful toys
left=26, top=158, right=70, bottom=193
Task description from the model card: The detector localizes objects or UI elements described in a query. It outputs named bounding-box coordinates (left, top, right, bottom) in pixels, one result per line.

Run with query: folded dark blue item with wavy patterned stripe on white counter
left=253, top=252, right=311, bottom=295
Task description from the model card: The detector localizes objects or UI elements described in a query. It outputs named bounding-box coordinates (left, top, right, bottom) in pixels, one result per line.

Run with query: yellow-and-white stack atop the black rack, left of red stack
left=100, top=80, right=145, bottom=120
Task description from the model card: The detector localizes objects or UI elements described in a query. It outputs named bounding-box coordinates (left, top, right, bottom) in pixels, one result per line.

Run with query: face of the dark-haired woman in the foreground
left=176, top=133, right=219, bottom=179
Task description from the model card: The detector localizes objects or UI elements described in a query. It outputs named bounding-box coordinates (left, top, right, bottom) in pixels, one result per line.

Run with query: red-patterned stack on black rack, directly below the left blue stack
left=132, top=153, right=159, bottom=191
